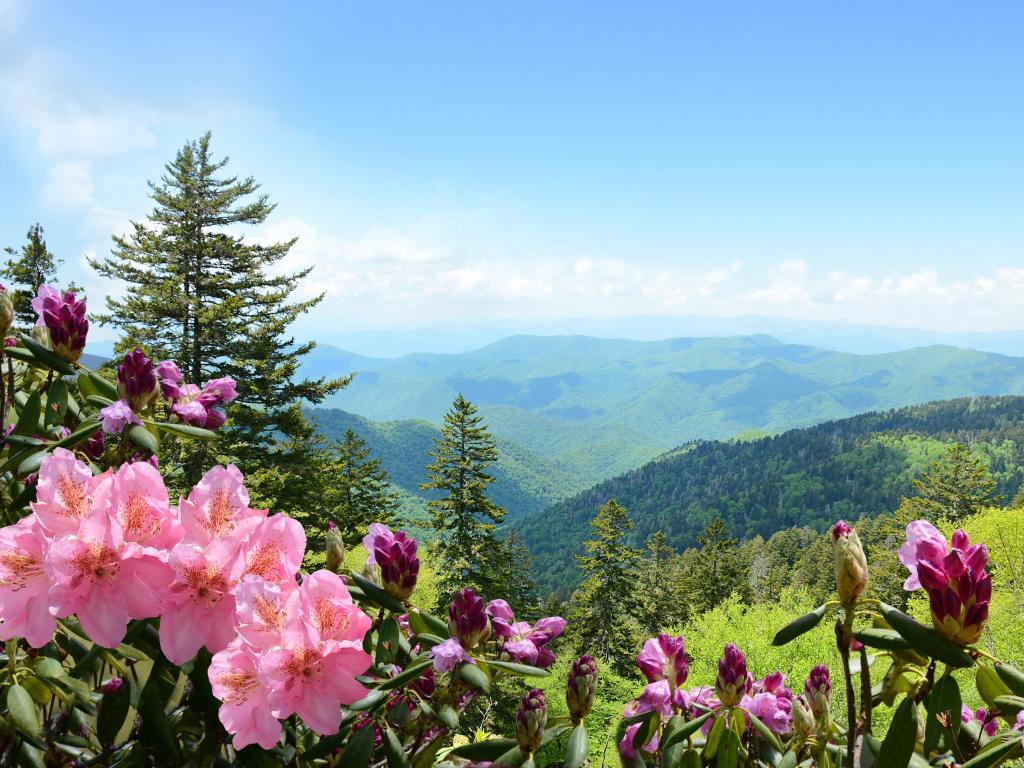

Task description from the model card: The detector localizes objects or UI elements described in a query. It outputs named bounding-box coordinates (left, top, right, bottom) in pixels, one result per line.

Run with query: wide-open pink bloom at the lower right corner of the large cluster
left=259, top=621, right=372, bottom=735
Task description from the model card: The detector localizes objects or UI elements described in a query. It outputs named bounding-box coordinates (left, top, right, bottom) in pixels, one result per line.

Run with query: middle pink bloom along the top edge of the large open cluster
left=96, top=462, right=182, bottom=550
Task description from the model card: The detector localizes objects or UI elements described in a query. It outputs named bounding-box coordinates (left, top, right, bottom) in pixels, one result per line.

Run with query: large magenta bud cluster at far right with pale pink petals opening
left=899, top=520, right=992, bottom=645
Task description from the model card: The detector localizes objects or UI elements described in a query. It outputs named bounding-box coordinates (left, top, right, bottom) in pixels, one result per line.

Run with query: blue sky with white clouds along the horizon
left=0, top=0, right=1024, bottom=339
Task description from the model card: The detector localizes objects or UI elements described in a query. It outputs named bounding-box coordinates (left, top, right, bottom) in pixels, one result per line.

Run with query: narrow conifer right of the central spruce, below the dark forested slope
left=569, top=500, right=643, bottom=675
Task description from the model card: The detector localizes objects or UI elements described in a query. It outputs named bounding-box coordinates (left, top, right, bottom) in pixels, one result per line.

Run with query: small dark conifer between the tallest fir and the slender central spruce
left=329, top=429, right=398, bottom=545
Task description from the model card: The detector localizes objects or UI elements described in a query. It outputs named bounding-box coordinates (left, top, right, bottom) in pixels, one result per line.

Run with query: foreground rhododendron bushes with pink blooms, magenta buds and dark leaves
left=0, top=287, right=1024, bottom=768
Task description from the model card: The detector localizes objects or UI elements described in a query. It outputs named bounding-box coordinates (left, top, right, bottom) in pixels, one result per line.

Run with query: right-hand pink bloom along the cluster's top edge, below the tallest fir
left=180, top=464, right=266, bottom=544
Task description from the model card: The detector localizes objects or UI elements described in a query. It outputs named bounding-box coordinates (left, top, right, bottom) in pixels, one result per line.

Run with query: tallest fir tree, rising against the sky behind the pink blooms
left=90, top=133, right=348, bottom=501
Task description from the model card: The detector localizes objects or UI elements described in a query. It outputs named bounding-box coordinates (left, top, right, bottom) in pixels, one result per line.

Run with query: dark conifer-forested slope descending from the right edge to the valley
left=516, top=397, right=1024, bottom=589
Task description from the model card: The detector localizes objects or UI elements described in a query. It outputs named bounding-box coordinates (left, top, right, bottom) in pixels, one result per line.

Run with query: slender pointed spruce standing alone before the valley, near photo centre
left=421, top=394, right=505, bottom=607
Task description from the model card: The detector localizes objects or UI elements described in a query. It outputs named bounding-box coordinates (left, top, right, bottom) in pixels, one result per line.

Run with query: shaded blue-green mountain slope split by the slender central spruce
left=307, top=409, right=590, bottom=523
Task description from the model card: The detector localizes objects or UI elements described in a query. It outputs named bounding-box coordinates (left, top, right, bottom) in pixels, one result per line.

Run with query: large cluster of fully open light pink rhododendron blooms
left=0, top=449, right=371, bottom=748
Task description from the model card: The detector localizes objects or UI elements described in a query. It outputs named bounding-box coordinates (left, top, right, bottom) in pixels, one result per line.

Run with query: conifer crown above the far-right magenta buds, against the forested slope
left=899, top=442, right=1006, bottom=522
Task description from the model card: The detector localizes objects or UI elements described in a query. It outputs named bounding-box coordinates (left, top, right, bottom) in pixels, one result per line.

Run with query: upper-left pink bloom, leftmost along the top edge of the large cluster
left=32, top=447, right=101, bottom=537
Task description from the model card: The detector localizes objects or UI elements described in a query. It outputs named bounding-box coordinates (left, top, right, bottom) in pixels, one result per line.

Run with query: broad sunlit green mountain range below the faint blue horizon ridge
left=302, top=336, right=1024, bottom=480
